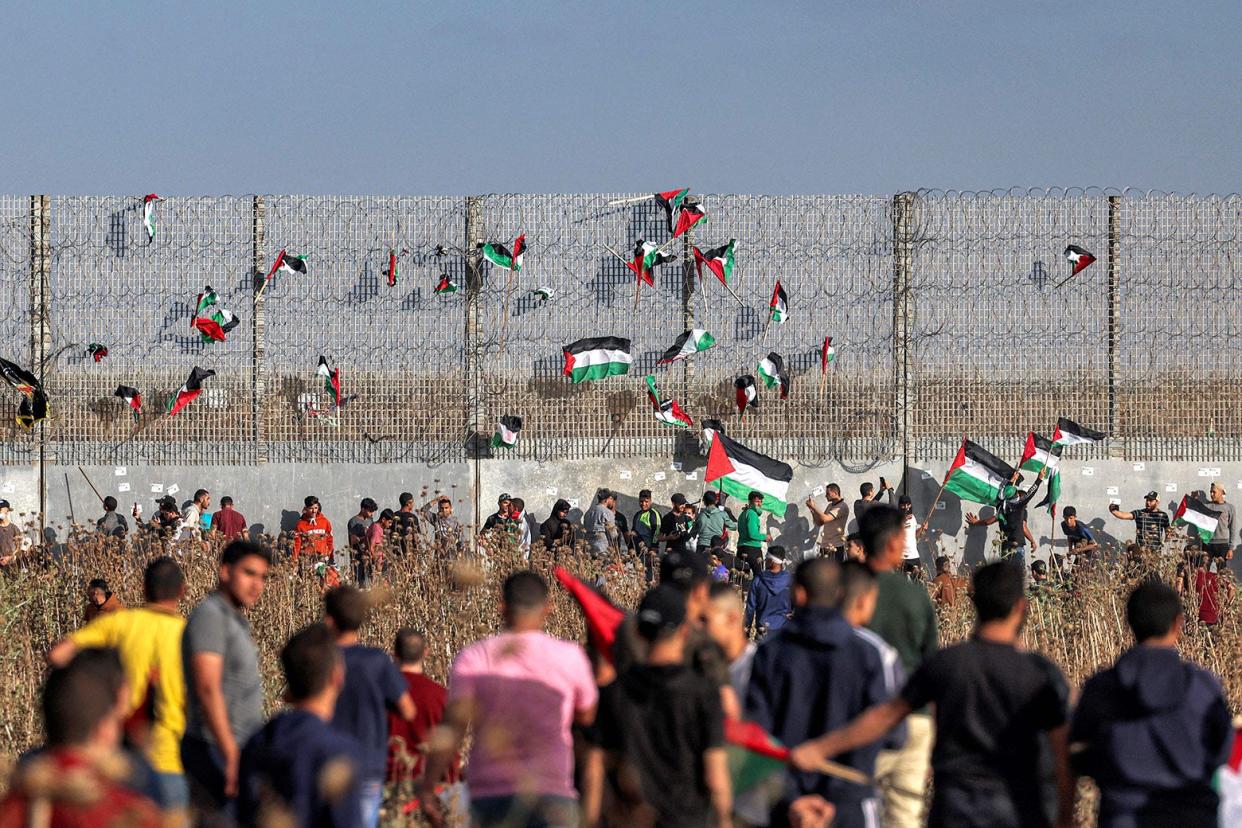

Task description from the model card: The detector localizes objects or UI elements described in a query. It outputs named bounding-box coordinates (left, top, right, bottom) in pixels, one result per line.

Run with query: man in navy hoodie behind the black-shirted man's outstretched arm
left=746, top=557, right=892, bottom=828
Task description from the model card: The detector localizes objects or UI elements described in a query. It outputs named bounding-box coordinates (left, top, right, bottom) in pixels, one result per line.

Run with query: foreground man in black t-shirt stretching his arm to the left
left=791, top=561, right=1074, bottom=828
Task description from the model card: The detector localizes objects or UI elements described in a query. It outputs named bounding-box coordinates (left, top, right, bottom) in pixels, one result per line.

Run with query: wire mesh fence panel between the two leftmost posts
left=45, top=196, right=255, bottom=463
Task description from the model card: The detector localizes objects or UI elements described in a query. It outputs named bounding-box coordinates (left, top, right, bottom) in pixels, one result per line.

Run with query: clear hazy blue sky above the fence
left=0, top=0, right=1242, bottom=195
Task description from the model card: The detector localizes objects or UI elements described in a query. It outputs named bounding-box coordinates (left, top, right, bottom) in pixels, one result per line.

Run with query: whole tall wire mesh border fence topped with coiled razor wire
left=0, top=190, right=1242, bottom=467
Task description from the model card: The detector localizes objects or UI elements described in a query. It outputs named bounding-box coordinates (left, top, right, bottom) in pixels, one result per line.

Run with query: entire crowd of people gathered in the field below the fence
left=0, top=471, right=1242, bottom=828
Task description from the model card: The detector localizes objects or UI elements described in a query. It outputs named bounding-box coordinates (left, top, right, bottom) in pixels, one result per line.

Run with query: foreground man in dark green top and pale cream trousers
left=858, top=505, right=939, bottom=828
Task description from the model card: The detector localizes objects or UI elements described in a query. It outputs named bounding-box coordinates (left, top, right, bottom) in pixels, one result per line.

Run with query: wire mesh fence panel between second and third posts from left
left=261, top=196, right=467, bottom=463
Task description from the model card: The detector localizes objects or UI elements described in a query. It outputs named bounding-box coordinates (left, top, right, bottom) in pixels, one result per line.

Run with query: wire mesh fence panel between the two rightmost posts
left=910, top=191, right=1108, bottom=459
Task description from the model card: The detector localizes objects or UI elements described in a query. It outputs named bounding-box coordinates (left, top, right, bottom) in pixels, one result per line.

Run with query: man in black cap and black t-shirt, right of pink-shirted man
left=600, top=583, right=733, bottom=826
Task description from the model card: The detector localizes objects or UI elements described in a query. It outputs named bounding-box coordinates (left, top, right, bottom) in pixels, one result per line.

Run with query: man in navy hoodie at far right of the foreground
left=1069, top=581, right=1231, bottom=828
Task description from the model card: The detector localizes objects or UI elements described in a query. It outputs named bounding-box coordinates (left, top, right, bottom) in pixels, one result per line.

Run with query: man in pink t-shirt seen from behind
left=421, top=571, right=599, bottom=828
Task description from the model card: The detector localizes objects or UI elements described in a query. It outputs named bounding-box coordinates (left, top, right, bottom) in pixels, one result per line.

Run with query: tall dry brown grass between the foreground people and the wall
left=0, top=535, right=1242, bottom=824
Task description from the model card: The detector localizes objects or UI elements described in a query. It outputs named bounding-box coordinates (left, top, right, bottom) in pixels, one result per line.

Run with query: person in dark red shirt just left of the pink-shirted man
left=388, top=627, right=461, bottom=785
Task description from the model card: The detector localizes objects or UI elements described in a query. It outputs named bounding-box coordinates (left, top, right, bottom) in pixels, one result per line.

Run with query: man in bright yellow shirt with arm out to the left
left=47, top=557, right=189, bottom=809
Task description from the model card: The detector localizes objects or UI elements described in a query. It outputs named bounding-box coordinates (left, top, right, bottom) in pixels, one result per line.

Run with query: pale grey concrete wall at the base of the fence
left=0, top=452, right=1242, bottom=571
